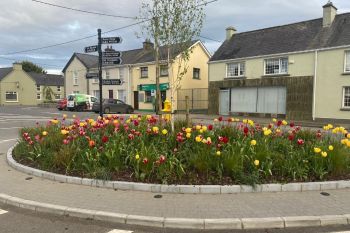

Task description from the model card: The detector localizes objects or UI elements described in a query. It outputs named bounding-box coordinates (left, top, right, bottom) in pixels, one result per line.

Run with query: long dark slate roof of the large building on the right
left=210, top=13, right=350, bottom=61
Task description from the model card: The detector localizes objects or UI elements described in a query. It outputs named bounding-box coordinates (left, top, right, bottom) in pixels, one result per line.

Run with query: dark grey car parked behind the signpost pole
left=92, top=99, right=134, bottom=114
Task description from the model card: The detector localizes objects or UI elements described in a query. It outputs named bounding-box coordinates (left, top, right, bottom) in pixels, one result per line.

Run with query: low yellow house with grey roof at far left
left=0, top=63, right=64, bottom=105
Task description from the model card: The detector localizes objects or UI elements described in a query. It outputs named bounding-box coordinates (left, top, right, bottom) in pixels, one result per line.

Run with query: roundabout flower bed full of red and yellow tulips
left=13, top=115, right=350, bottom=185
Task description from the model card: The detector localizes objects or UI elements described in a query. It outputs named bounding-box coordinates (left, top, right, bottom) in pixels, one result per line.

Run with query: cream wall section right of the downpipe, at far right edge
left=315, top=46, right=350, bottom=120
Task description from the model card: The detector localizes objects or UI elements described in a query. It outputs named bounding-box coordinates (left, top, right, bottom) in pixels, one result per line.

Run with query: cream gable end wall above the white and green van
left=64, top=57, right=88, bottom=96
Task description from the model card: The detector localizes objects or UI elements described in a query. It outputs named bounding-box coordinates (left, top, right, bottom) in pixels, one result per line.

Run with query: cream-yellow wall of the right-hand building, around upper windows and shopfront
left=209, top=46, right=350, bottom=120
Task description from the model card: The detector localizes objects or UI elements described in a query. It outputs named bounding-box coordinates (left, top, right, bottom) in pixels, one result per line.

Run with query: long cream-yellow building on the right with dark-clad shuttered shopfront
left=209, top=2, right=350, bottom=122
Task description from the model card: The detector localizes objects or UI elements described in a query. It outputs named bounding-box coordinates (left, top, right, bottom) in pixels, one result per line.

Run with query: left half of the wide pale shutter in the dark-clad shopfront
left=231, top=87, right=258, bottom=113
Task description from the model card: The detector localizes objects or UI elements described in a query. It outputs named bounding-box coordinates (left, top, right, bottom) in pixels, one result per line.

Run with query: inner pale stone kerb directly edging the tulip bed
left=7, top=146, right=350, bottom=194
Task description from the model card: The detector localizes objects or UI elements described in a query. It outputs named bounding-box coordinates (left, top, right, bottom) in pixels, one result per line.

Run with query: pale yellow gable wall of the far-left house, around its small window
left=0, top=68, right=37, bottom=105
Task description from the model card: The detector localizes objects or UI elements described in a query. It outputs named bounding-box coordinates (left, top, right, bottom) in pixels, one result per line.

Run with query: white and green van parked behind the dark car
left=67, top=94, right=97, bottom=111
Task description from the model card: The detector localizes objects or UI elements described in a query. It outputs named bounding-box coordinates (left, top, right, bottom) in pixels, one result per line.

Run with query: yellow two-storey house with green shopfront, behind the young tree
left=130, top=41, right=210, bottom=111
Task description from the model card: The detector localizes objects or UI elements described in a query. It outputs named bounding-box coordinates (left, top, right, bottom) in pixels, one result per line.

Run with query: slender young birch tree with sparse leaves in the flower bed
left=141, top=0, right=207, bottom=128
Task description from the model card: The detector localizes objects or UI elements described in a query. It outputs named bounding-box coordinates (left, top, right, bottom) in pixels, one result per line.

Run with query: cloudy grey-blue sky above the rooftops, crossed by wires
left=0, top=0, right=350, bottom=72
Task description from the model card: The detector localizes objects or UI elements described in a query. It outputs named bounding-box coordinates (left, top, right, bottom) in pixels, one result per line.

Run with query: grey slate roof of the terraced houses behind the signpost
left=62, top=41, right=197, bottom=73
